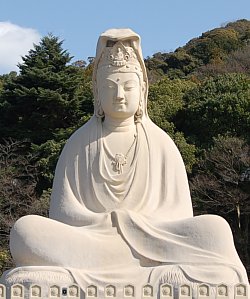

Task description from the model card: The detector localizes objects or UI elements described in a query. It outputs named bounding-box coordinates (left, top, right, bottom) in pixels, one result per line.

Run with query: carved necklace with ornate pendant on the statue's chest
left=103, top=133, right=137, bottom=174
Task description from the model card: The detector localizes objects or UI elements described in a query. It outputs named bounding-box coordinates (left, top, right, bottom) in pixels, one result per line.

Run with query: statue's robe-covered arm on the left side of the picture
left=49, top=127, right=105, bottom=226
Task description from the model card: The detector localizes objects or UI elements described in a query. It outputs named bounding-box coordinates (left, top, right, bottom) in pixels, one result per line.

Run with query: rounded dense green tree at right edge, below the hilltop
left=180, top=74, right=250, bottom=147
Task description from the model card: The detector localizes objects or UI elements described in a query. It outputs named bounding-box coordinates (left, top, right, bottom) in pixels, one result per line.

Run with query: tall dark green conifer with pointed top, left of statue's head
left=0, top=35, right=91, bottom=144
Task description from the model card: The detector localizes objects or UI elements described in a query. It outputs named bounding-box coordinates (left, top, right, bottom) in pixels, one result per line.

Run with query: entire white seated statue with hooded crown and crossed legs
left=0, top=29, right=248, bottom=298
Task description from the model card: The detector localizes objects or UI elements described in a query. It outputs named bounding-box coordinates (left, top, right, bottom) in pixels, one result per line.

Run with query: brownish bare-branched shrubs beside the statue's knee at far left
left=0, top=139, right=48, bottom=271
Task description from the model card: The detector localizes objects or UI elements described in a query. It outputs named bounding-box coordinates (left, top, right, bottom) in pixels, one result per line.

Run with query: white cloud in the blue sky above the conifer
left=0, top=22, right=41, bottom=74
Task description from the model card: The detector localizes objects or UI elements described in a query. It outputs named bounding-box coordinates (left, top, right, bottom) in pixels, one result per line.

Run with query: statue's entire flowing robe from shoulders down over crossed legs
left=10, top=116, right=248, bottom=289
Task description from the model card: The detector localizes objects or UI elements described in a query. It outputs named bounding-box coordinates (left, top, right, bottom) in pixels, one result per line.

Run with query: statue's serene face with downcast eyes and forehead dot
left=97, top=73, right=141, bottom=119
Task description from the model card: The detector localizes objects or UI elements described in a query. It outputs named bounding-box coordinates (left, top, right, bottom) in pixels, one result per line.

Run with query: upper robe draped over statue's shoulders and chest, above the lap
left=50, top=117, right=193, bottom=226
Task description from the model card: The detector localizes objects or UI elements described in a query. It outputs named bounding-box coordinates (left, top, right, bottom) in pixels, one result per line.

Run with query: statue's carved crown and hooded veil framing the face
left=93, top=29, right=148, bottom=117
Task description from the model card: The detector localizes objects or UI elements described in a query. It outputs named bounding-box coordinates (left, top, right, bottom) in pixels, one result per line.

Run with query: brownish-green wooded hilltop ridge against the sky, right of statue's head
left=145, top=20, right=250, bottom=79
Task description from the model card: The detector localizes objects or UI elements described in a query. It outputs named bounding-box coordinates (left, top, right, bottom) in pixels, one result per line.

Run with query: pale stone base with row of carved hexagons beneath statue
left=0, top=266, right=248, bottom=299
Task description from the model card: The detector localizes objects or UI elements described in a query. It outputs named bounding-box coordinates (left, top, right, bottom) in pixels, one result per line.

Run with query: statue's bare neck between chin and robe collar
left=103, top=116, right=135, bottom=132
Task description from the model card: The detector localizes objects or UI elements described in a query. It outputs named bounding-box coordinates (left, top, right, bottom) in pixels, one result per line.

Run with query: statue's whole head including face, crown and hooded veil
left=93, top=29, right=148, bottom=122
